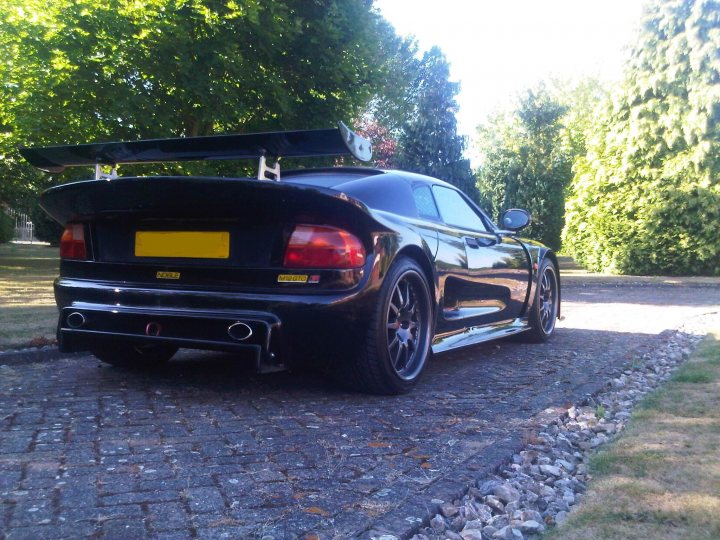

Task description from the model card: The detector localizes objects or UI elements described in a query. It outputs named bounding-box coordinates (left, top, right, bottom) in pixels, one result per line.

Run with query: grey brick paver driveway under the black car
left=0, top=276, right=720, bottom=539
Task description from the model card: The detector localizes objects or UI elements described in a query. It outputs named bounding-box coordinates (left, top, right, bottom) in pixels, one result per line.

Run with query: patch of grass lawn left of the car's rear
left=0, top=244, right=59, bottom=350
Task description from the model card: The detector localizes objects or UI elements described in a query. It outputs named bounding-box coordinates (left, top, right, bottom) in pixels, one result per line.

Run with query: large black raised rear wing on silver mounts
left=20, top=122, right=372, bottom=180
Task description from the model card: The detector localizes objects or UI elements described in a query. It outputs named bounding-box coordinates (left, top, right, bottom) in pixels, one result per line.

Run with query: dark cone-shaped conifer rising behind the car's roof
left=396, top=47, right=475, bottom=197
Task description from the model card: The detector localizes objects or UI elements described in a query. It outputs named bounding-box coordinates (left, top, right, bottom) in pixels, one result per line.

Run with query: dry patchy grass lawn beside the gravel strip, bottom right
left=545, top=329, right=720, bottom=540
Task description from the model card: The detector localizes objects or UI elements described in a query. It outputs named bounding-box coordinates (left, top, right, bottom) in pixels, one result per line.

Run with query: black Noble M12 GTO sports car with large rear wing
left=21, top=124, right=560, bottom=394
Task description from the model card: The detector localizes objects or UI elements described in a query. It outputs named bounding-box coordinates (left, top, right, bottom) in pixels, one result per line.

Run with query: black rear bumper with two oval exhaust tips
left=55, top=278, right=375, bottom=366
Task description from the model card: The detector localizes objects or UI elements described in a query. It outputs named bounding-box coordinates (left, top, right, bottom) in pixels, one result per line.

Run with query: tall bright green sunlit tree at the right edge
left=564, top=0, right=720, bottom=275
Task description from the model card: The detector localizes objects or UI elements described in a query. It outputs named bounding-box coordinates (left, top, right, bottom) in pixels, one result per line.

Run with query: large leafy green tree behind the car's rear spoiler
left=0, top=0, right=401, bottom=210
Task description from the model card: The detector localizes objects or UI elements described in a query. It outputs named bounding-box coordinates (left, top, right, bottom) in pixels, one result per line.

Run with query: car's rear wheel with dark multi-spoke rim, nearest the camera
left=344, top=257, right=433, bottom=395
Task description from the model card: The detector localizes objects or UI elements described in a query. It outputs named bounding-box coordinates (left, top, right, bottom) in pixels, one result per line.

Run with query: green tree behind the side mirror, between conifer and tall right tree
left=478, top=86, right=572, bottom=249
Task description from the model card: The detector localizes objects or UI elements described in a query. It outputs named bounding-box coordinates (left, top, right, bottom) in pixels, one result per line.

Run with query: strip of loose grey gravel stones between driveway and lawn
left=404, top=313, right=720, bottom=540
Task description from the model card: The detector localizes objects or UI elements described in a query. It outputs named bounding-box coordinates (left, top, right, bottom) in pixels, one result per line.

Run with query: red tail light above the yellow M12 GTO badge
left=283, top=225, right=365, bottom=268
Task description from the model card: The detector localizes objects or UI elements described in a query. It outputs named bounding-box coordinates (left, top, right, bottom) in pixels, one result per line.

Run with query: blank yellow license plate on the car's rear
left=135, top=231, right=230, bottom=259
